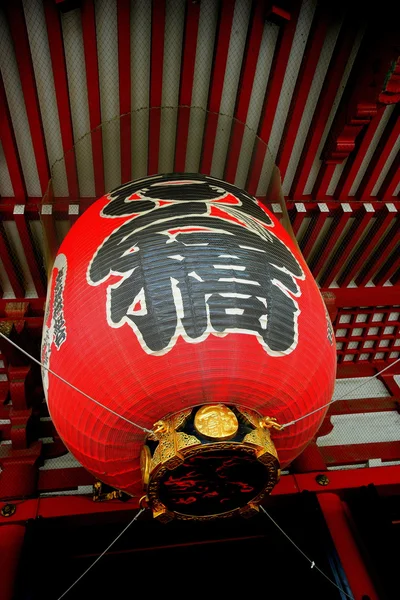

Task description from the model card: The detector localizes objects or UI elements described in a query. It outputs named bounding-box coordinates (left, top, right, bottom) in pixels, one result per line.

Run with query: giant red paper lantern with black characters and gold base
left=42, top=174, right=336, bottom=518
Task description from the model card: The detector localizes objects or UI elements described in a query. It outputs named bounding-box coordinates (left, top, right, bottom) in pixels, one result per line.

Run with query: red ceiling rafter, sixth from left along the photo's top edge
left=175, top=1, right=200, bottom=173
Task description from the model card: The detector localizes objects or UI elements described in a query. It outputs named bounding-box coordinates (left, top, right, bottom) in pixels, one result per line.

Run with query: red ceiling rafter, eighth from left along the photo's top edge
left=224, top=0, right=265, bottom=183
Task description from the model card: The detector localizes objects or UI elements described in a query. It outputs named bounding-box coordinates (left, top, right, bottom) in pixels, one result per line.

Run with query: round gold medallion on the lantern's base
left=194, top=404, right=239, bottom=440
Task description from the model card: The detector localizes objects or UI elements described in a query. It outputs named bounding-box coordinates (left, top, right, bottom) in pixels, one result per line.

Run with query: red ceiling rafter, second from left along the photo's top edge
left=43, top=0, right=79, bottom=198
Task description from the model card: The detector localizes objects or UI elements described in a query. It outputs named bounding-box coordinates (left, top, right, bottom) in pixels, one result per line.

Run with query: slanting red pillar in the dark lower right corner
left=318, top=493, right=379, bottom=600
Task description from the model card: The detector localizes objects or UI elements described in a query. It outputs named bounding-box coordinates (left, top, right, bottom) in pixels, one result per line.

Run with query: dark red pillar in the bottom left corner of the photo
left=0, top=524, right=25, bottom=600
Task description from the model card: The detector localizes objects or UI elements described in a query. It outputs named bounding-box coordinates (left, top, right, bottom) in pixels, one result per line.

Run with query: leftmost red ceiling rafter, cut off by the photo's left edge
left=0, top=73, right=27, bottom=203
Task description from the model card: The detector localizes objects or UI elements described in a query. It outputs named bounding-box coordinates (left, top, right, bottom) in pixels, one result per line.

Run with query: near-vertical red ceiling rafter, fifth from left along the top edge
left=147, top=0, right=166, bottom=175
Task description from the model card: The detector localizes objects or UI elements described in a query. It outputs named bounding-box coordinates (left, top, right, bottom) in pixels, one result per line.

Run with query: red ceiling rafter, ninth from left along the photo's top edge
left=246, top=2, right=301, bottom=195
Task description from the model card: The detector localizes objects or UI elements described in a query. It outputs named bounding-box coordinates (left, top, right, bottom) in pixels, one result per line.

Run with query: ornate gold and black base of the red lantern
left=141, top=404, right=280, bottom=522
